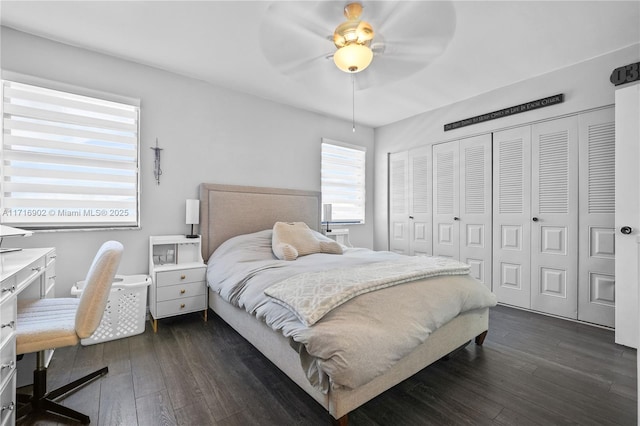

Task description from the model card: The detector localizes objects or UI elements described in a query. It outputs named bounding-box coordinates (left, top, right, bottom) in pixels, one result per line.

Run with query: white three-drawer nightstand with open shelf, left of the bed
left=149, top=235, right=208, bottom=332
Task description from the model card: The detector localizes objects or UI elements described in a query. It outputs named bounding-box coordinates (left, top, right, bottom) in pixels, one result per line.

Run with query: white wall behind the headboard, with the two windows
left=0, top=28, right=374, bottom=296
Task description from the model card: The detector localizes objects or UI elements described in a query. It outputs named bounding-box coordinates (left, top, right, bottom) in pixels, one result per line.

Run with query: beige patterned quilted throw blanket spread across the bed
left=265, top=257, right=469, bottom=326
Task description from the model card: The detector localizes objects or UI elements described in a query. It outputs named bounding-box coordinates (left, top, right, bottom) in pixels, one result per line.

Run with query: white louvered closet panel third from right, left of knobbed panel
left=493, top=126, right=531, bottom=308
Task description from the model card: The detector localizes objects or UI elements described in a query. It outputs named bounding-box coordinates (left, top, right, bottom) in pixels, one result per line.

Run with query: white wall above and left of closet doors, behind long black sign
left=374, top=44, right=640, bottom=250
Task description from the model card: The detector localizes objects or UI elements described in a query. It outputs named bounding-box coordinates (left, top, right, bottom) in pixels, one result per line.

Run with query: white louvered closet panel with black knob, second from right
left=531, top=116, right=578, bottom=318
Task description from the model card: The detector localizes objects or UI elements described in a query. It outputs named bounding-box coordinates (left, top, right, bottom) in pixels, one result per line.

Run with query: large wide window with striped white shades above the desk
left=0, top=80, right=139, bottom=229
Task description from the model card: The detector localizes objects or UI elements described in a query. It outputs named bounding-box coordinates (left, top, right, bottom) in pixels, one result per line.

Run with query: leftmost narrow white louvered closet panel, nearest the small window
left=389, top=151, right=409, bottom=254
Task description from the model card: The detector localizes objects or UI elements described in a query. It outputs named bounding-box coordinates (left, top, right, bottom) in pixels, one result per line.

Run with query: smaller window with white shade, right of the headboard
left=321, top=139, right=367, bottom=224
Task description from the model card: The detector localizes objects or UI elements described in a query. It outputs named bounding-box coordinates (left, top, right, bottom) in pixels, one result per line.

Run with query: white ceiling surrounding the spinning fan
left=0, top=0, right=640, bottom=127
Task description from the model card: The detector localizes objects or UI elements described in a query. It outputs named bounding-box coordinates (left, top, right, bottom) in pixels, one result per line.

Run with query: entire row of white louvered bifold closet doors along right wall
left=389, top=108, right=615, bottom=327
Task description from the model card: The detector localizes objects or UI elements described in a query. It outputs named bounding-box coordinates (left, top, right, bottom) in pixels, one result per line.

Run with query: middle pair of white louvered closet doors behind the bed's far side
left=433, top=134, right=491, bottom=288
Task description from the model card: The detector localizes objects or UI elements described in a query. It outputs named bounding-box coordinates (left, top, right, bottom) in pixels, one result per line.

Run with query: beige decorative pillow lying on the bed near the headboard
left=271, top=222, right=342, bottom=260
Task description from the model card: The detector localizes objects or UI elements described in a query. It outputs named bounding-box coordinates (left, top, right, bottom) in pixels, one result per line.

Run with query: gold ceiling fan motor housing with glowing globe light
left=333, top=3, right=374, bottom=73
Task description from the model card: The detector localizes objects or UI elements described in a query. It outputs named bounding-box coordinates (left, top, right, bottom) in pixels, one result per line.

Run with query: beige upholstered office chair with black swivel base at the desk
left=16, top=241, right=123, bottom=424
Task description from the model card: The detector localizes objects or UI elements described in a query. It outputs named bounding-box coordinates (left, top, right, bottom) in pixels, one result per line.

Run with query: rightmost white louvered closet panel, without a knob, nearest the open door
left=578, top=108, right=616, bottom=327
